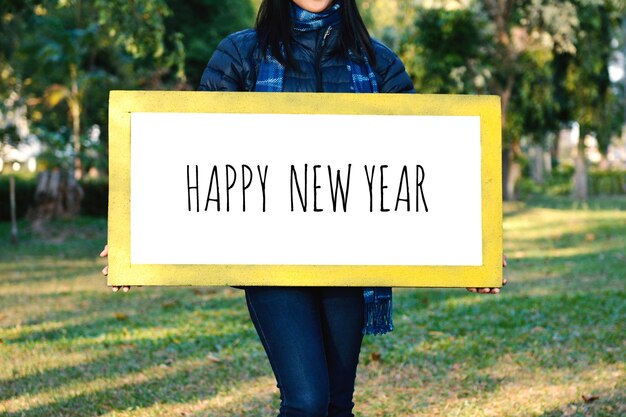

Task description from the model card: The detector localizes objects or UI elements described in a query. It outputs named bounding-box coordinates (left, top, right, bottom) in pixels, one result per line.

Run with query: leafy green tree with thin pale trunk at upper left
left=0, top=0, right=184, bottom=178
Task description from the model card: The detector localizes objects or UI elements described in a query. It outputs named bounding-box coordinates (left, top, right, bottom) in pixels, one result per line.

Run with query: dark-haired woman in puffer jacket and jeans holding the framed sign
left=103, top=0, right=497, bottom=417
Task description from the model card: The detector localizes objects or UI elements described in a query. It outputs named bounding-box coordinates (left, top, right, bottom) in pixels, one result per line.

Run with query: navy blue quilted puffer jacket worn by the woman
left=199, top=25, right=415, bottom=93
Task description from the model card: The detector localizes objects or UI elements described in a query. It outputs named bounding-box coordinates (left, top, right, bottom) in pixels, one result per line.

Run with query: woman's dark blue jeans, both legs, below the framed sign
left=245, top=287, right=363, bottom=417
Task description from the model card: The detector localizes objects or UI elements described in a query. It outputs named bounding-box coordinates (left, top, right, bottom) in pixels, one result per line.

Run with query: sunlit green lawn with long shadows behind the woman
left=0, top=198, right=626, bottom=417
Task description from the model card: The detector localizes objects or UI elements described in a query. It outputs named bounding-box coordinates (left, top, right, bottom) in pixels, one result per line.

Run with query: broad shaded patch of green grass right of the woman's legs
left=389, top=282, right=626, bottom=369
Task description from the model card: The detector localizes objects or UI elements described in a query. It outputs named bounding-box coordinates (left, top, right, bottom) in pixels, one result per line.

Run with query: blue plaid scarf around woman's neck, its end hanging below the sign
left=255, top=2, right=393, bottom=334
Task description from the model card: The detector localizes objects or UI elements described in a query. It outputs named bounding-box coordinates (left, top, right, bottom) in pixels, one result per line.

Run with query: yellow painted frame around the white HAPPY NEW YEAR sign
left=108, top=91, right=502, bottom=287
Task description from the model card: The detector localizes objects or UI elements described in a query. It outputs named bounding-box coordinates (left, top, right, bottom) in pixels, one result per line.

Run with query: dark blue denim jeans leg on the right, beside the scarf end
left=321, top=287, right=364, bottom=417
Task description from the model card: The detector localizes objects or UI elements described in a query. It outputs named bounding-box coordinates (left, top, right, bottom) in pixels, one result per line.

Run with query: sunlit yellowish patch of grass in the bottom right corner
left=356, top=358, right=625, bottom=417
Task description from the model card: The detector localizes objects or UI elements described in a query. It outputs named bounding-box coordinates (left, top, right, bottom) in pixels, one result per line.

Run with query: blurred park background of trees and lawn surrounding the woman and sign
left=0, top=0, right=626, bottom=416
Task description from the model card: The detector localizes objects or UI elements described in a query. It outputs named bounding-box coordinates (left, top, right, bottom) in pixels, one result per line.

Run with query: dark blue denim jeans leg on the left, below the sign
left=246, top=287, right=330, bottom=417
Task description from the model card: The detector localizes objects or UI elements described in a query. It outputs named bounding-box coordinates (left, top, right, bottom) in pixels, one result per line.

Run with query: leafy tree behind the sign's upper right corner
left=388, top=0, right=578, bottom=199
